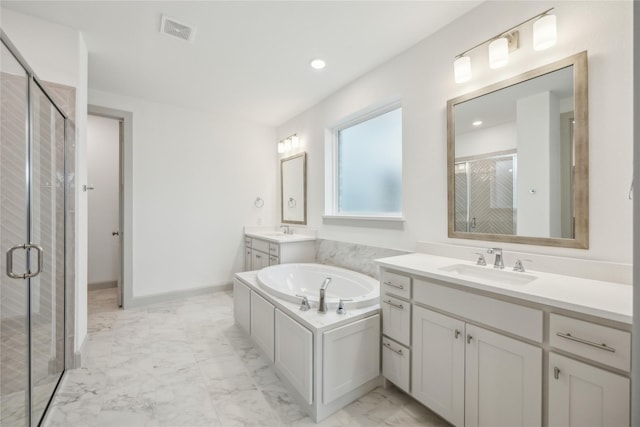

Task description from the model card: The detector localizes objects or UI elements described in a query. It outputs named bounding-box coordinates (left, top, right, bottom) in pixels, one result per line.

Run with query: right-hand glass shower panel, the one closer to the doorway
left=29, top=81, right=65, bottom=423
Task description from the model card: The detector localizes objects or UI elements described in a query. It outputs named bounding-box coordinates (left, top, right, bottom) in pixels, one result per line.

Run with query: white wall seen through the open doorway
left=87, top=115, right=120, bottom=284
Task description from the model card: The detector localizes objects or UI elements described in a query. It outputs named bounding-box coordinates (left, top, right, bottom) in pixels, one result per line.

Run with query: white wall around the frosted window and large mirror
left=278, top=1, right=633, bottom=263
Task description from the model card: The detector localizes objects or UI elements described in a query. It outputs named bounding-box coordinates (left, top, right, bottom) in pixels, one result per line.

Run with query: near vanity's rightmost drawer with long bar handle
left=549, top=313, right=631, bottom=372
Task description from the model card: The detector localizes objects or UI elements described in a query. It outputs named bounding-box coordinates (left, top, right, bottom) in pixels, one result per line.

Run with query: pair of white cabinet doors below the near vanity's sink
left=411, top=306, right=542, bottom=427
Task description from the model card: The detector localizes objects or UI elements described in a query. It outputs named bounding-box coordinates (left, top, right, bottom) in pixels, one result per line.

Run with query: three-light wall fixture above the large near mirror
left=453, top=8, right=556, bottom=83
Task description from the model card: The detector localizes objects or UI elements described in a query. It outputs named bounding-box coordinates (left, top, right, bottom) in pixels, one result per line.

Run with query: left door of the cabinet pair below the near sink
left=411, top=306, right=465, bottom=426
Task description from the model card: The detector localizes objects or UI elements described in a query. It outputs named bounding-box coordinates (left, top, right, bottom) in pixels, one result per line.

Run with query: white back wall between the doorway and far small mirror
left=89, top=89, right=277, bottom=298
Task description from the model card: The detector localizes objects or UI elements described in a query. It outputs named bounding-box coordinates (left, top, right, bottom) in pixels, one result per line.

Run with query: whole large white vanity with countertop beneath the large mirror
left=377, top=254, right=632, bottom=427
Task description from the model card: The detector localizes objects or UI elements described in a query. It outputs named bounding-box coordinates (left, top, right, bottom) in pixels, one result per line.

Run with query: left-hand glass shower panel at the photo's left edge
left=0, top=39, right=30, bottom=426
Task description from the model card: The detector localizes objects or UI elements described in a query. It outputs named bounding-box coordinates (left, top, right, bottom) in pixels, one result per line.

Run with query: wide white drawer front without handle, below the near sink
left=413, top=279, right=542, bottom=342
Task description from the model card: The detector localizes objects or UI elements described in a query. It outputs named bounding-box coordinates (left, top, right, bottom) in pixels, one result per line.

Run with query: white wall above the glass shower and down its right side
left=0, top=8, right=88, bottom=351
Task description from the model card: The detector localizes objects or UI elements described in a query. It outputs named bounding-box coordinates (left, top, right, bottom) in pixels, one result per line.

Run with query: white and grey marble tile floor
left=44, top=289, right=448, bottom=427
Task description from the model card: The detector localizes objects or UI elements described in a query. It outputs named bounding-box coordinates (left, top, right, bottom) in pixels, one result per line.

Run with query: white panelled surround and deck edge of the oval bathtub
left=234, top=272, right=380, bottom=421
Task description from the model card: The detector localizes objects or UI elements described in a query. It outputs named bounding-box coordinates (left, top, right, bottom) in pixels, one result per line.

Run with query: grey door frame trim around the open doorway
left=87, top=104, right=133, bottom=309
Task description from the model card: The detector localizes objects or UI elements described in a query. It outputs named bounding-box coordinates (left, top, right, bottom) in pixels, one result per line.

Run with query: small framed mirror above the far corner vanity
left=280, top=153, right=307, bottom=224
